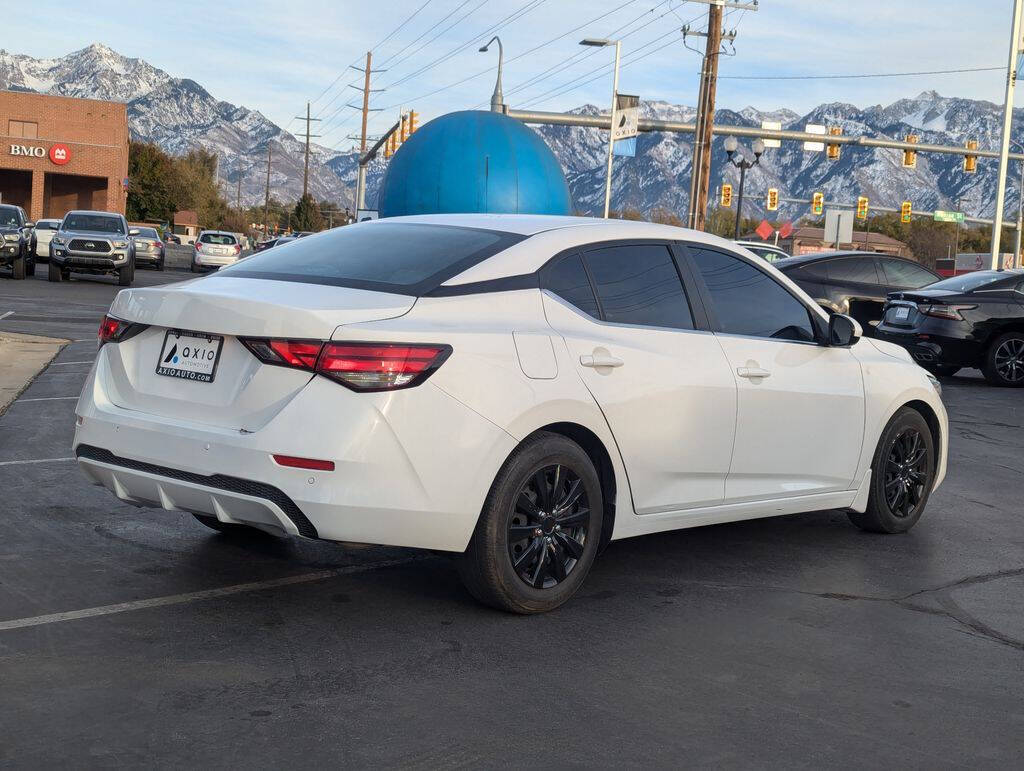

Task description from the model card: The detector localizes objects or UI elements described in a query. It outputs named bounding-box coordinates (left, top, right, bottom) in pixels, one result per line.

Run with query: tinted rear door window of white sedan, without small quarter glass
left=587, top=244, right=693, bottom=330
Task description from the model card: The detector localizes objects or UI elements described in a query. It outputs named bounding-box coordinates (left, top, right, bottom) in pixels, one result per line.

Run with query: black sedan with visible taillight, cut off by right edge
left=876, top=270, right=1024, bottom=386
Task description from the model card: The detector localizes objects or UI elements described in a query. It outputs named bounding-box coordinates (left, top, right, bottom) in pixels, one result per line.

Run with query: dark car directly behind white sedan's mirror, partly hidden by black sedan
left=772, top=252, right=942, bottom=335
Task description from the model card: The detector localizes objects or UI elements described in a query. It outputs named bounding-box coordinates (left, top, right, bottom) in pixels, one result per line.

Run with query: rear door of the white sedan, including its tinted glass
left=541, top=242, right=736, bottom=514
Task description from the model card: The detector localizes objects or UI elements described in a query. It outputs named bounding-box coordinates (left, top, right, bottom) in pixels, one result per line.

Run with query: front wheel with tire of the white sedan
left=849, top=406, right=936, bottom=533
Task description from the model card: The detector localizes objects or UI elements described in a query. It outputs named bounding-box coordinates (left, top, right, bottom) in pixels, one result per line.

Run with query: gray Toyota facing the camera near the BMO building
left=48, top=211, right=138, bottom=287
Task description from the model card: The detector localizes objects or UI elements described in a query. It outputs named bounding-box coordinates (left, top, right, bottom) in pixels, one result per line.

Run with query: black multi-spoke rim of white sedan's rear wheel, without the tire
left=508, top=464, right=590, bottom=589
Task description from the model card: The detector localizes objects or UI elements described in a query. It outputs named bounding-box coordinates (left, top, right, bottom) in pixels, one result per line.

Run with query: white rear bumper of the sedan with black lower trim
left=75, top=356, right=515, bottom=552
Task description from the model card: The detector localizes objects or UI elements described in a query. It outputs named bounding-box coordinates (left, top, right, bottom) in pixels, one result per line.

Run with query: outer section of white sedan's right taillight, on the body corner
left=316, top=342, right=452, bottom=391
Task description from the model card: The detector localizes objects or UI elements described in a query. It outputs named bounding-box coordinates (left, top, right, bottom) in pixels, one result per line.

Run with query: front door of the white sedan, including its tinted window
left=687, top=244, right=864, bottom=503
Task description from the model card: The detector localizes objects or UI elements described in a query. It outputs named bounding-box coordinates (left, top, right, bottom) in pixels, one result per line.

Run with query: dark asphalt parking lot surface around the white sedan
left=0, top=270, right=1024, bottom=768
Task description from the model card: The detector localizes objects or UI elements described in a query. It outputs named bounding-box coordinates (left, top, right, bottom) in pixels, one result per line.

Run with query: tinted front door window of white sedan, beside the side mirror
left=689, top=246, right=815, bottom=342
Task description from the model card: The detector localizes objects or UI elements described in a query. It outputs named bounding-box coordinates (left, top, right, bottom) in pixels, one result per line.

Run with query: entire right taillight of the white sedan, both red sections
left=240, top=338, right=452, bottom=391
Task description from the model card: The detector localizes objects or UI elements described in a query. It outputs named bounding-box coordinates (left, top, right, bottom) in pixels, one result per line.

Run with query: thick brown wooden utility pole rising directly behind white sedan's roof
left=684, top=0, right=758, bottom=230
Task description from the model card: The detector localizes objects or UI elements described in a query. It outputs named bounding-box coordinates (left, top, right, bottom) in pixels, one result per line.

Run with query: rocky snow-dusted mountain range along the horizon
left=0, top=44, right=1024, bottom=217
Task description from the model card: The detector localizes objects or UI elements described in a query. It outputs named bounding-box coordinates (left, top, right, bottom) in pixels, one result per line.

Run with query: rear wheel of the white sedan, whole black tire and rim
left=459, top=432, right=604, bottom=613
